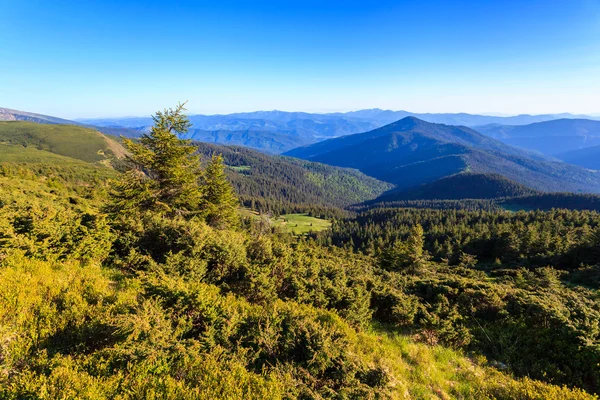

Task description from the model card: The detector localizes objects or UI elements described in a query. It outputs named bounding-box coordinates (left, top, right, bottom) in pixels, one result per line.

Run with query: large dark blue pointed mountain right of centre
left=285, top=117, right=600, bottom=192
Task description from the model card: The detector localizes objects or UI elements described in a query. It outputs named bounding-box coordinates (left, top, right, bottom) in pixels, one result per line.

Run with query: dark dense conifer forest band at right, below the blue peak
left=315, top=208, right=600, bottom=269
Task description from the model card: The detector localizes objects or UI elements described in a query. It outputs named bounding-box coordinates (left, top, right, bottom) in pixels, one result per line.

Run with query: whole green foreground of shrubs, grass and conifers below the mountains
left=0, top=106, right=600, bottom=399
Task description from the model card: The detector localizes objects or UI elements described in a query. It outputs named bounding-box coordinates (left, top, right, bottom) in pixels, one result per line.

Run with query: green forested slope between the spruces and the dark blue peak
left=198, top=143, right=391, bottom=212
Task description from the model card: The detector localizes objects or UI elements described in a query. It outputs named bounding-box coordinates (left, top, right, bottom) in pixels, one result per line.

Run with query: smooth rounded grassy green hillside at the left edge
left=0, top=121, right=124, bottom=162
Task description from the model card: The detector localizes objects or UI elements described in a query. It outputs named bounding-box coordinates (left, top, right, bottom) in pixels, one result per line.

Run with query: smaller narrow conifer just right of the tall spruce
left=203, top=154, right=239, bottom=228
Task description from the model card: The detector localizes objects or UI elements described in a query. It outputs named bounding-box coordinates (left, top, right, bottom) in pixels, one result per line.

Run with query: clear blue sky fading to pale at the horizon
left=0, top=0, right=600, bottom=118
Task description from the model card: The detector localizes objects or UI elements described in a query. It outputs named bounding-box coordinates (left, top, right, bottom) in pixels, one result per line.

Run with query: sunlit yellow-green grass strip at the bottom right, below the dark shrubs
left=351, top=328, right=597, bottom=400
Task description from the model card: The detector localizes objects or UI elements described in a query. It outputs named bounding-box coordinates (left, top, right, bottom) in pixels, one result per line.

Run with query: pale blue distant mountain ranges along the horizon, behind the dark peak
left=0, top=108, right=600, bottom=154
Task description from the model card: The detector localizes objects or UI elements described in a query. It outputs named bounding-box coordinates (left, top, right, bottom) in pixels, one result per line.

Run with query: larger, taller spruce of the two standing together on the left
left=111, top=103, right=203, bottom=216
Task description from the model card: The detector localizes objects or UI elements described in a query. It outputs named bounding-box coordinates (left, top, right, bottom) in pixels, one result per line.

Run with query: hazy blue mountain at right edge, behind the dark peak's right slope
left=474, top=118, right=600, bottom=155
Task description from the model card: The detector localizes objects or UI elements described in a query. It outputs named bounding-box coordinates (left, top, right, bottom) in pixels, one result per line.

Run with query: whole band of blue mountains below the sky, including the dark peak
left=0, top=104, right=600, bottom=204
